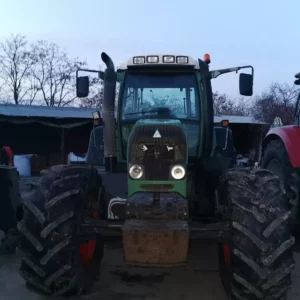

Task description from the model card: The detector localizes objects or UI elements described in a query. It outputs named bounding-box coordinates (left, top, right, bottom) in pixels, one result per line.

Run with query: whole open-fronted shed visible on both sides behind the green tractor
left=0, top=104, right=270, bottom=169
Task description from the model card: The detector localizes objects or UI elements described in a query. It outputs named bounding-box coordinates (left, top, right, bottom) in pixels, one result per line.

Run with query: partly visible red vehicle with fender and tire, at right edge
left=261, top=73, right=300, bottom=241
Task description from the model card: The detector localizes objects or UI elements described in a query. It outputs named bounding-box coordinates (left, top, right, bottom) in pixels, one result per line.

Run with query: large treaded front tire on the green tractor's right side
left=219, top=168, right=295, bottom=300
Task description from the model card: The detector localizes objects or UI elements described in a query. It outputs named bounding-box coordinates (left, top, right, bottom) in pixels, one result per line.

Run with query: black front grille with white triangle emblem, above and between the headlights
left=128, top=124, right=187, bottom=180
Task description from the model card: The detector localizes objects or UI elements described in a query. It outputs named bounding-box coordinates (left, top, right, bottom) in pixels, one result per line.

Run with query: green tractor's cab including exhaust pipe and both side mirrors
left=77, top=53, right=253, bottom=171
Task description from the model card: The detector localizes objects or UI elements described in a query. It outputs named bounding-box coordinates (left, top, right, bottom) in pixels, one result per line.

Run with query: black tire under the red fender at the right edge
left=261, top=140, right=300, bottom=242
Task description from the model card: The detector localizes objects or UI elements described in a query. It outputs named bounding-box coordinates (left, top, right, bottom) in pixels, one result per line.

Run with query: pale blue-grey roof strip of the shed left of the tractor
left=0, top=104, right=95, bottom=119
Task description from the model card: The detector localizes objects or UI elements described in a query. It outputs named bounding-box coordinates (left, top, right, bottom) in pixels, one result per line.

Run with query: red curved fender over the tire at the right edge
left=263, top=125, right=300, bottom=168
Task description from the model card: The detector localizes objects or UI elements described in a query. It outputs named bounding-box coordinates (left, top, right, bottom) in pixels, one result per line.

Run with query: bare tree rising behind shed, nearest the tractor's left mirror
left=31, top=41, right=85, bottom=106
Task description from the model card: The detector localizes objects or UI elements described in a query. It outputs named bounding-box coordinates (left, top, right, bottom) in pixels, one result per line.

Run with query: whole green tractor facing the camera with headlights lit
left=17, top=53, right=294, bottom=300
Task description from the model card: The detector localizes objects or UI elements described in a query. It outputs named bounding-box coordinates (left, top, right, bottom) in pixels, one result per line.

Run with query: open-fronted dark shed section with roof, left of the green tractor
left=0, top=104, right=94, bottom=169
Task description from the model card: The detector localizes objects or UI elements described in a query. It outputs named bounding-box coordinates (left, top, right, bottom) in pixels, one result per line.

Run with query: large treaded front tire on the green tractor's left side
left=17, top=166, right=104, bottom=296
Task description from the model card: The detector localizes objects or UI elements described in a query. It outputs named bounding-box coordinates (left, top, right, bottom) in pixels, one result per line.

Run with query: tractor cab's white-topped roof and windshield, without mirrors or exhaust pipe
left=117, top=55, right=203, bottom=160
